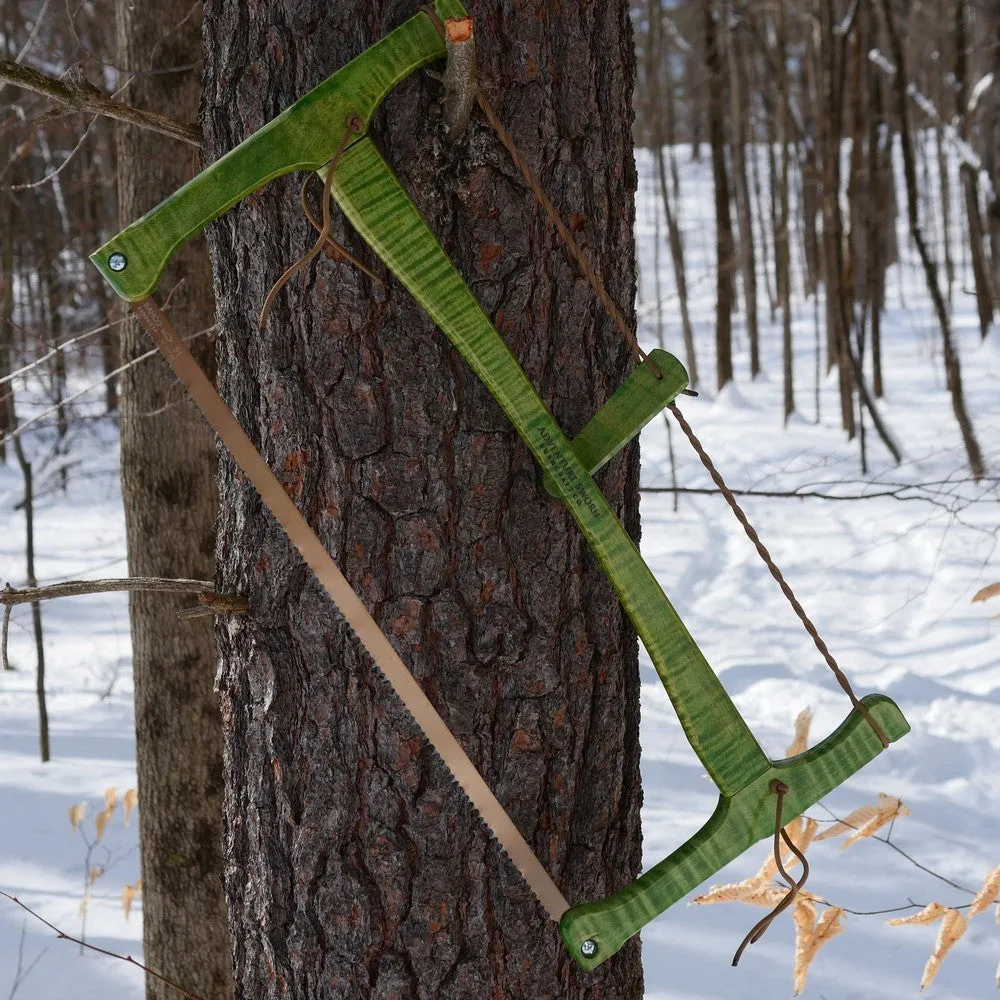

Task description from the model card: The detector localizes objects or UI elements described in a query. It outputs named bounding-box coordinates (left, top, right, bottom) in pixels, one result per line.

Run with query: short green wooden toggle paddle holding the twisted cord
left=543, top=349, right=688, bottom=497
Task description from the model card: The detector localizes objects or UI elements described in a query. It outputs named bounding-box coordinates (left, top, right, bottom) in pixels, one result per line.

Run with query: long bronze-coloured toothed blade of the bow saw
left=132, top=298, right=569, bottom=921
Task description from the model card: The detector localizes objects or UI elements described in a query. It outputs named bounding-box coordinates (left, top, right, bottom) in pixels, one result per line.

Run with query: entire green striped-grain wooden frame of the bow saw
left=91, top=0, right=909, bottom=969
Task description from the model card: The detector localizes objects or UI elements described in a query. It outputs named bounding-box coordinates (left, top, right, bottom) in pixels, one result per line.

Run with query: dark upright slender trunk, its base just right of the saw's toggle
left=701, top=0, right=736, bottom=389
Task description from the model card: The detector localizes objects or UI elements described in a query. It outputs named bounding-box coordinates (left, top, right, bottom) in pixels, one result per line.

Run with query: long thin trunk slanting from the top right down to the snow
left=882, top=0, right=983, bottom=480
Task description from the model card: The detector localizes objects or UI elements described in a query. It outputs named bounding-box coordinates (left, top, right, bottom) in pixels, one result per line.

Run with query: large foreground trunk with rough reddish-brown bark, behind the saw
left=203, top=0, right=642, bottom=1000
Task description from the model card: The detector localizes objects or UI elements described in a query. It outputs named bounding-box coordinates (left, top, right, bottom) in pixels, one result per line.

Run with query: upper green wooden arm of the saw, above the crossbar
left=90, top=0, right=466, bottom=302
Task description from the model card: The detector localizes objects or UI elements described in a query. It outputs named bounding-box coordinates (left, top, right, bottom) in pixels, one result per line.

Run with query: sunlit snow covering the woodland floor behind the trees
left=0, top=143, right=1000, bottom=1000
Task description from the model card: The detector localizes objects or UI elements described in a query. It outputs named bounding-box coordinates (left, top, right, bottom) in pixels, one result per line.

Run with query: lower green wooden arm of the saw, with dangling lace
left=559, top=694, right=910, bottom=969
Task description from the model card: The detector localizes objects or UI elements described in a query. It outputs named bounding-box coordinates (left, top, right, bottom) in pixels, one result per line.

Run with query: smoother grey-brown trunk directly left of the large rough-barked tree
left=117, top=0, right=232, bottom=1000
